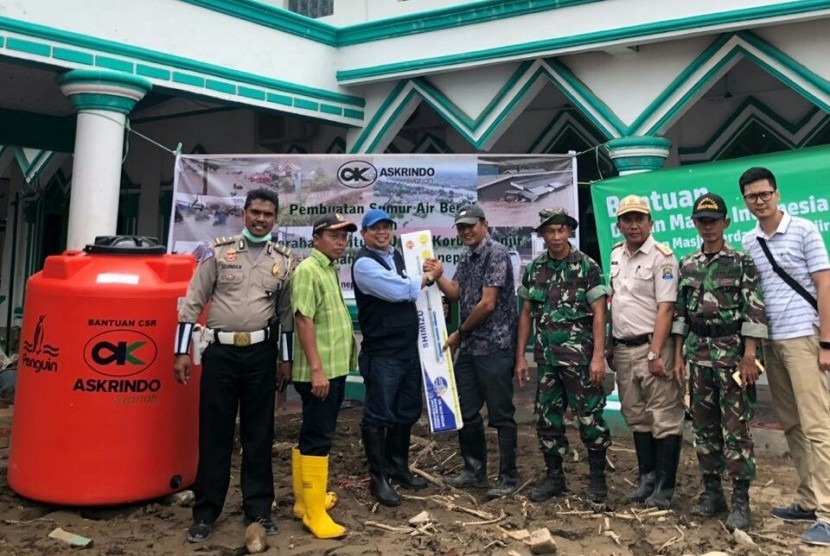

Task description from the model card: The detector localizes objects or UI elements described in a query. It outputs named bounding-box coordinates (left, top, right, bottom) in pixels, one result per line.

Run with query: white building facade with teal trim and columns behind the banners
left=0, top=0, right=830, bottom=336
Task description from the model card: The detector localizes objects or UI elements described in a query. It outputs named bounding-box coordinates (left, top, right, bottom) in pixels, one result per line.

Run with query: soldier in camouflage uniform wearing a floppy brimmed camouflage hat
left=516, top=208, right=611, bottom=502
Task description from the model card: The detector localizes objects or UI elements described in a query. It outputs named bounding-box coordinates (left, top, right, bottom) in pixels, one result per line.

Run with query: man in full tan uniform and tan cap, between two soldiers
left=611, top=195, right=685, bottom=508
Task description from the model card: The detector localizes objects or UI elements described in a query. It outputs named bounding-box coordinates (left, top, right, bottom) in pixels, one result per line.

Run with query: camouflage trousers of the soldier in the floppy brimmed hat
left=536, top=365, right=611, bottom=457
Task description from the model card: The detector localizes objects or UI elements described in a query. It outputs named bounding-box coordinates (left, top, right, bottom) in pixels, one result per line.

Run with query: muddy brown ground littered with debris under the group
left=0, top=407, right=830, bottom=556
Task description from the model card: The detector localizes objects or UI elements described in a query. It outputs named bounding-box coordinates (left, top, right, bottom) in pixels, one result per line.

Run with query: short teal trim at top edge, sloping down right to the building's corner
left=180, top=0, right=338, bottom=46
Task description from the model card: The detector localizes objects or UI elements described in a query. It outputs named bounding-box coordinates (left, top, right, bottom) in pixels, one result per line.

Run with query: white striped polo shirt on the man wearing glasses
left=743, top=211, right=830, bottom=340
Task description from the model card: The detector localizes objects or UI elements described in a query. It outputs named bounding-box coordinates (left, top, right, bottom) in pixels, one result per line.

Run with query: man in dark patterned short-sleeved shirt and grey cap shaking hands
left=424, top=205, right=518, bottom=498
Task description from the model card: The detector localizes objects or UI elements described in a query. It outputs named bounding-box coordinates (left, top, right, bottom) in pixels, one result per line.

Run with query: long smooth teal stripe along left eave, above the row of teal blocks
left=0, top=16, right=365, bottom=108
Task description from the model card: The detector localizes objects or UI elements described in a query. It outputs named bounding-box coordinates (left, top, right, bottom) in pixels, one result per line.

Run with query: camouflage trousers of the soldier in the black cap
left=689, top=365, right=755, bottom=480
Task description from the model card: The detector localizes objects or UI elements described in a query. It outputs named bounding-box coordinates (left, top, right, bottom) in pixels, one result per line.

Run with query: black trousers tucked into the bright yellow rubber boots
left=294, top=376, right=346, bottom=456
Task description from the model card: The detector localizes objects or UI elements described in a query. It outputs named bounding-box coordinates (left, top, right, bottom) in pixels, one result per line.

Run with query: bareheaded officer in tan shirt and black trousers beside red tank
left=174, top=189, right=294, bottom=542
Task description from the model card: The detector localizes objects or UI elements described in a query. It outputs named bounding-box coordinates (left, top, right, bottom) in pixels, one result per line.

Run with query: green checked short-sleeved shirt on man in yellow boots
left=291, top=249, right=357, bottom=382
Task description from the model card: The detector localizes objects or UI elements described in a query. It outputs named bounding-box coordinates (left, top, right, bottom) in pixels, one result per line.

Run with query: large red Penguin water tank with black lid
left=8, top=236, right=200, bottom=505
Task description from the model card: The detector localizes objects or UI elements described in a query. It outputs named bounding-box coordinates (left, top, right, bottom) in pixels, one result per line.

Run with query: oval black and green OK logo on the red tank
left=84, top=329, right=158, bottom=378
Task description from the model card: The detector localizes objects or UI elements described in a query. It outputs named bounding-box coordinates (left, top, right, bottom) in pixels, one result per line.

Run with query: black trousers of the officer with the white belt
left=193, top=342, right=277, bottom=523
